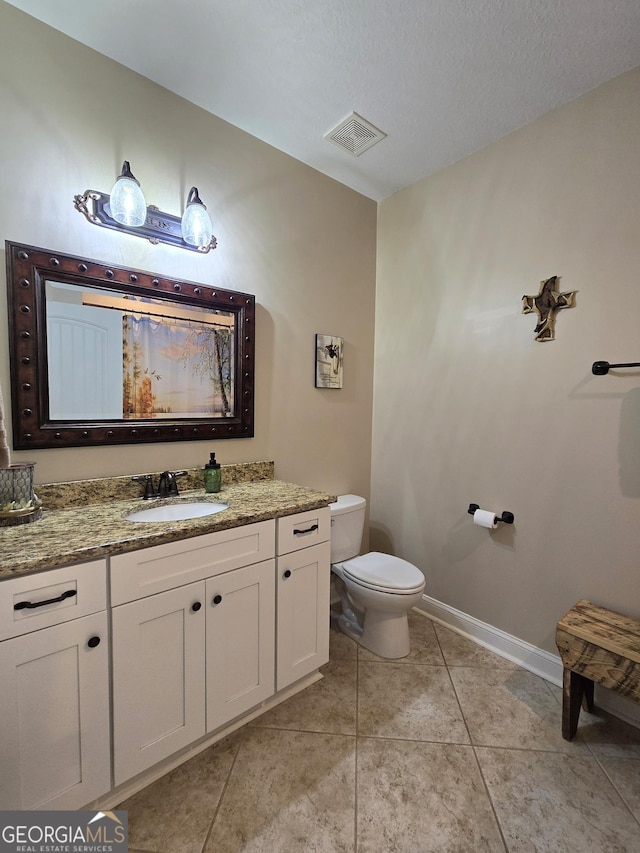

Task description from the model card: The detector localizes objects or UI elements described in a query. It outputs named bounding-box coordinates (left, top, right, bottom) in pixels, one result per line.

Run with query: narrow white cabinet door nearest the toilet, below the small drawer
left=276, top=542, right=331, bottom=690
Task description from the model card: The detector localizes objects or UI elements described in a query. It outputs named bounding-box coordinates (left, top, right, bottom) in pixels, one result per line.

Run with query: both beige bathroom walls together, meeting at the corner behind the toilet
left=0, top=3, right=640, bottom=651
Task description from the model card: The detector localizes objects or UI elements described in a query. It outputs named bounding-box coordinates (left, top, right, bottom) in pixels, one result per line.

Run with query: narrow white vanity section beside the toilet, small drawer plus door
left=276, top=507, right=331, bottom=690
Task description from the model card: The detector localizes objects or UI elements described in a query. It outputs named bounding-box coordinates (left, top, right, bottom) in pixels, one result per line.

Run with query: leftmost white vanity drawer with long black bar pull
left=0, top=560, right=107, bottom=640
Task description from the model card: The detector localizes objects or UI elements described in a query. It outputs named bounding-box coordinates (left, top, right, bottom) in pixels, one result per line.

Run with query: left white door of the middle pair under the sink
left=112, top=581, right=205, bottom=785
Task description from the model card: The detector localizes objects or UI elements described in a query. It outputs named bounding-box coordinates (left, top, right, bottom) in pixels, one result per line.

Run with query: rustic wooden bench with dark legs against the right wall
left=556, top=601, right=640, bottom=740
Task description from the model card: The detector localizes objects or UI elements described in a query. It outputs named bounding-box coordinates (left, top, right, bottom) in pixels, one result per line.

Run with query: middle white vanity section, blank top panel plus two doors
left=111, top=521, right=275, bottom=785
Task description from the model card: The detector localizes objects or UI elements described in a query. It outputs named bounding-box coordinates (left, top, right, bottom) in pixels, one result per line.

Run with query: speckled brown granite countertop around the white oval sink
left=0, top=479, right=336, bottom=580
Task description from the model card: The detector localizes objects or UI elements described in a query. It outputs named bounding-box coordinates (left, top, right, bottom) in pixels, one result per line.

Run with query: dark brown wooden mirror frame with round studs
left=6, top=241, right=255, bottom=450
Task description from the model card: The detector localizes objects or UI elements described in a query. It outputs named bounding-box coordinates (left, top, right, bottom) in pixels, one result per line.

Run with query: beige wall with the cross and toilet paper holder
left=371, top=69, right=640, bottom=652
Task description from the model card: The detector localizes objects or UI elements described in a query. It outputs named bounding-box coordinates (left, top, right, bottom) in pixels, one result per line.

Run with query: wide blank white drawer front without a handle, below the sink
left=110, top=521, right=275, bottom=606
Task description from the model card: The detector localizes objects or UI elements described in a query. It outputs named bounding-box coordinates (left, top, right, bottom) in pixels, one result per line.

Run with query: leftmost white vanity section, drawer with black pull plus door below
left=0, top=560, right=111, bottom=810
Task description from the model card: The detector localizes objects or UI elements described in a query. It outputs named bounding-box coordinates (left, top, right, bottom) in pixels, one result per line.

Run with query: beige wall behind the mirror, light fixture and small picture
left=0, top=3, right=376, bottom=495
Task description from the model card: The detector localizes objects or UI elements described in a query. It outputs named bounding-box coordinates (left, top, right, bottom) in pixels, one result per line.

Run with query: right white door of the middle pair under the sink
left=207, top=560, right=275, bottom=732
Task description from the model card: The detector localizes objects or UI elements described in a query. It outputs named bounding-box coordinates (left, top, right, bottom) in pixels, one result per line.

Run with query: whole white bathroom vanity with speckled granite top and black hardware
left=0, top=470, right=334, bottom=809
